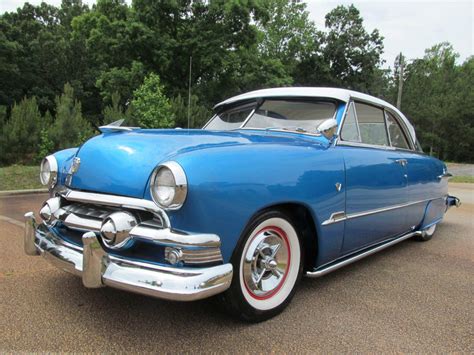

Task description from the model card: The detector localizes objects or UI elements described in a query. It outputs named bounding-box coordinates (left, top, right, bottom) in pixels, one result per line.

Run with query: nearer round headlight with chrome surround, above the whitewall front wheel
left=150, top=161, right=188, bottom=210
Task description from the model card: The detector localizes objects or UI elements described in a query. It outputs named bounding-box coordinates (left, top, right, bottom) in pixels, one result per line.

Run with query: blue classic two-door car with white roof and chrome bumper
left=25, top=88, right=460, bottom=321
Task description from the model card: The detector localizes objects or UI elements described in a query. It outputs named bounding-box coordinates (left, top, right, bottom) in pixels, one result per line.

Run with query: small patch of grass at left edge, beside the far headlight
left=0, top=164, right=44, bottom=191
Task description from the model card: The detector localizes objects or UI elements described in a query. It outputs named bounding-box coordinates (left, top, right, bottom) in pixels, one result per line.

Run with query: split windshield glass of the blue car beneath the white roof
left=205, top=99, right=336, bottom=132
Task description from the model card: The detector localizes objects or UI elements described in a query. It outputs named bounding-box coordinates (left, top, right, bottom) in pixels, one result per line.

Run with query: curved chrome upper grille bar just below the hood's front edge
left=61, top=190, right=171, bottom=228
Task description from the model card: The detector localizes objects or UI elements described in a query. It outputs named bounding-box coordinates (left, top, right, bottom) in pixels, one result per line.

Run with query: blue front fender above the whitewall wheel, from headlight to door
left=154, top=144, right=344, bottom=262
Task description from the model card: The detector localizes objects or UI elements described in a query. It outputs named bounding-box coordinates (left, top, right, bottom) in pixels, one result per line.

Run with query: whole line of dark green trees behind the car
left=0, top=0, right=474, bottom=164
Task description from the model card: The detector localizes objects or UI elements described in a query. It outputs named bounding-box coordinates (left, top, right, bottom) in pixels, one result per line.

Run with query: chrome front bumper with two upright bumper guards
left=24, top=212, right=232, bottom=301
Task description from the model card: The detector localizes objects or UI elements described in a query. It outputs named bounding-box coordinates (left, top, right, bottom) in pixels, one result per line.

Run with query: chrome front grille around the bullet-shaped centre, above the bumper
left=47, top=190, right=222, bottom=265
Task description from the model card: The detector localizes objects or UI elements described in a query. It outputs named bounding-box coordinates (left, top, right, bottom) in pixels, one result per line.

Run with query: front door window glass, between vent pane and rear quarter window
left=355, top=102, right=389, bottom=145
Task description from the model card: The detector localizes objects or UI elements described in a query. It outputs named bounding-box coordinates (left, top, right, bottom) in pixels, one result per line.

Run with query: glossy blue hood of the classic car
left=70, top=129, right=323, bottom=198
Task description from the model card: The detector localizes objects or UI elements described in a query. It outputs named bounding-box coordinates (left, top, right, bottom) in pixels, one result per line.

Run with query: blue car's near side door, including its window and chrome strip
left=337, top=102, right=411, bottom=254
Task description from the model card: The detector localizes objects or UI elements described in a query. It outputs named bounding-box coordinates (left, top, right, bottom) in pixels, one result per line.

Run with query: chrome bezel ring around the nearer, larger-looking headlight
left=150, top=161, right=188, bottom=210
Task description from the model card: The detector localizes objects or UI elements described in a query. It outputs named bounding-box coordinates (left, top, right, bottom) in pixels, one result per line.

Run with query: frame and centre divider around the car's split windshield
left=202, top=96, right=341, bottom=136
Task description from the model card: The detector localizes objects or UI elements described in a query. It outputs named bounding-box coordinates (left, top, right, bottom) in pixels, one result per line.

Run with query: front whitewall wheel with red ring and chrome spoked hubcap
left=222, top=211, right=303, bottom=322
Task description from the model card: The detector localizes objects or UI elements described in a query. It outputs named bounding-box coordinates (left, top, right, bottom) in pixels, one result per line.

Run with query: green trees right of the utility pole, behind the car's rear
left=402, top=43, right=474, bottom=162
